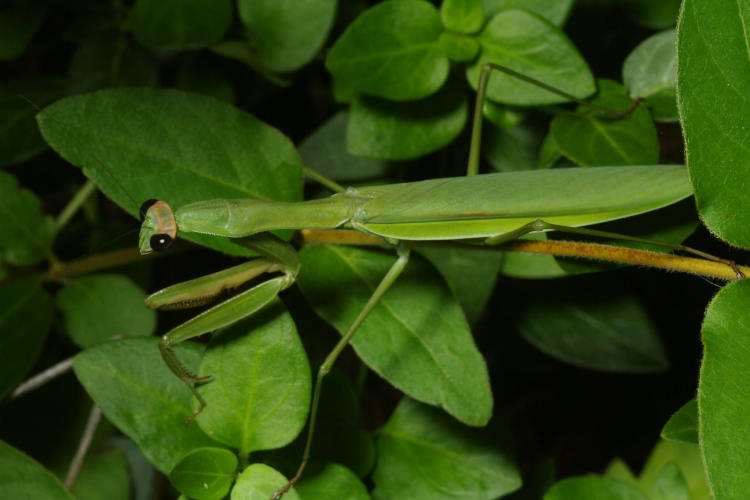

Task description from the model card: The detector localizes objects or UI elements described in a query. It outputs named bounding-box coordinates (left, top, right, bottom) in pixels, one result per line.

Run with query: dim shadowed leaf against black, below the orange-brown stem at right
left=517, top=279, right=669, bottom=373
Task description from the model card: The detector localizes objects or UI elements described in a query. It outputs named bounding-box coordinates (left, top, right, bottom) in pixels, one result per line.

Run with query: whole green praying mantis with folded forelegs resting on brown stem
left=36, top=61, right=742, bottom=499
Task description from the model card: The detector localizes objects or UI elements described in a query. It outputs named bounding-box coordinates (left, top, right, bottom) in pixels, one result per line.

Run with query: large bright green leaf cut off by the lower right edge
left=698, top=280, right=750, bottom=500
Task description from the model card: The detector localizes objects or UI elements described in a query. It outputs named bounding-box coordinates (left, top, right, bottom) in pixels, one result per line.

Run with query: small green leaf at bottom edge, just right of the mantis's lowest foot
left=296, top=463, right=370, bottom=500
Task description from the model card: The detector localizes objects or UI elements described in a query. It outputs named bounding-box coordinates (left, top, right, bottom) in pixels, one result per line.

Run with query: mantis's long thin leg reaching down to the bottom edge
left=271, top=246, right=409, bottom=500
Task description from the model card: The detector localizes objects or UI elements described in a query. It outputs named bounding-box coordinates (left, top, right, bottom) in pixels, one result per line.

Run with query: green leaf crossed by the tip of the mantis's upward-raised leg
left=550, top=80, right=659, bottom=167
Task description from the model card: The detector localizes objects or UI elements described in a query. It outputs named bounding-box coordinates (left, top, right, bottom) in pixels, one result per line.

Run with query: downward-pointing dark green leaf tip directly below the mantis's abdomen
left=418, top=247, right=503, bottom=325
